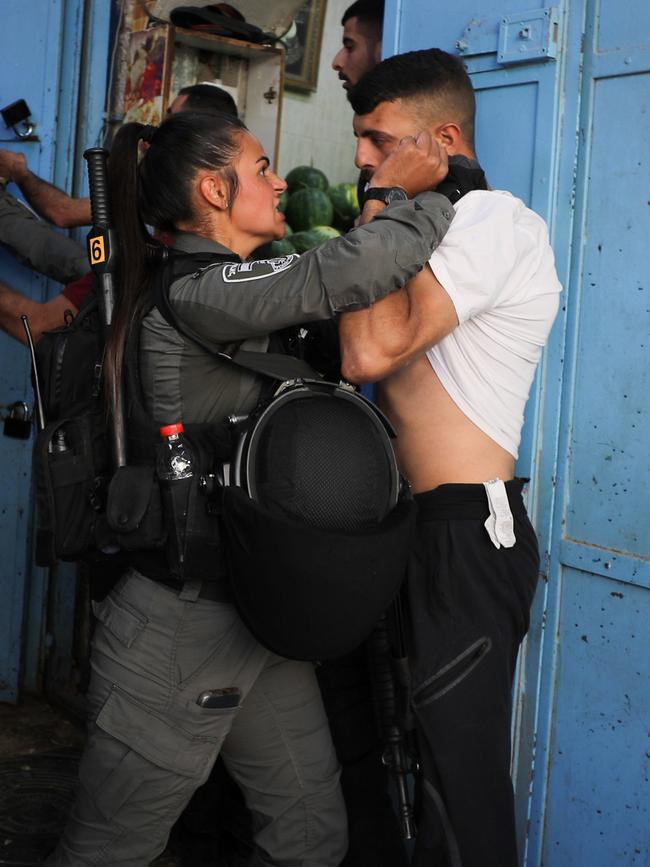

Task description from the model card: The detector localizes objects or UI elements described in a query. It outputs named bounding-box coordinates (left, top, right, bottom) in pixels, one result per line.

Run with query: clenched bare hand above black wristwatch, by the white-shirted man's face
left=369, top=130, right=448, bottom=198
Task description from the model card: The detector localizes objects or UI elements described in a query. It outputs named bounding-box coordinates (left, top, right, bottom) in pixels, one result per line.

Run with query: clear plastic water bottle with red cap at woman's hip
left=156, top=422, right=195, bottom=581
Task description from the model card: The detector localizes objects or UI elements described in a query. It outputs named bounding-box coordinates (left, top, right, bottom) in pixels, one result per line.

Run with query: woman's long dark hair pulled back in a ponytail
left=105, top=111, right=246, bottom=395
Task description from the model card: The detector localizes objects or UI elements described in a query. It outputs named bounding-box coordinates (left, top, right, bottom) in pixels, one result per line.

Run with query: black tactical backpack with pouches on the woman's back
left=33, top=268, right=231, bottom=583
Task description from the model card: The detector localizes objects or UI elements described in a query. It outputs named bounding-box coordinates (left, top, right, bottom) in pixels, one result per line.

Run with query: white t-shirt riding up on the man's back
left=427, top=190, right=562, bottom=458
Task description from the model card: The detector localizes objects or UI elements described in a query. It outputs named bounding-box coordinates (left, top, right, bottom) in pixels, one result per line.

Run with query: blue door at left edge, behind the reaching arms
left=0, top=0, right=110, bottom=701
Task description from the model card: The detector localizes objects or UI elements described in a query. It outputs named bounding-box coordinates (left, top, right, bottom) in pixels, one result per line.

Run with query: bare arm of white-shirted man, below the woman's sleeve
left=339, top=265, right=458, bottom=383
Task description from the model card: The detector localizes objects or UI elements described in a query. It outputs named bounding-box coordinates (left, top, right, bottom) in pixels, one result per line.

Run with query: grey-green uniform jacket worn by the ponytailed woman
left=140, top=193, right=453, bottom=424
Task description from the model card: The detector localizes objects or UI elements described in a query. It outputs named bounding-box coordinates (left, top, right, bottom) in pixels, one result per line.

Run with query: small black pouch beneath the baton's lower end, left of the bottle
left=106, top=466, right=165, bottom=551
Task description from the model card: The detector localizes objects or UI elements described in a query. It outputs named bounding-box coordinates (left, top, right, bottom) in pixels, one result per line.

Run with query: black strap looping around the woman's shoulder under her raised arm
left=153, top=251, right=322, bottom=381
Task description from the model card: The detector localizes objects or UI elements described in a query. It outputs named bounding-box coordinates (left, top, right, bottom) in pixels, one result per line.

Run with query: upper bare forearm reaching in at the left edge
left=0, top=149, right=91, bottom=229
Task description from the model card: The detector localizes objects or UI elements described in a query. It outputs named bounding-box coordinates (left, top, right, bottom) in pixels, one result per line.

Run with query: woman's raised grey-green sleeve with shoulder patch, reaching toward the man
left=170, top=193, right=454, bottom=343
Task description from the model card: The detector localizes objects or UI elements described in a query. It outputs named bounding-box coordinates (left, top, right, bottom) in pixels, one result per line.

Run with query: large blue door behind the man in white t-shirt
left=384, top=0, right=650, bottom=867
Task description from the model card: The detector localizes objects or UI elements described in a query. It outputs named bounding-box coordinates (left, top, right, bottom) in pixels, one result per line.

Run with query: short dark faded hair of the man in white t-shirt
left=348, top=48, right=476, bottom=150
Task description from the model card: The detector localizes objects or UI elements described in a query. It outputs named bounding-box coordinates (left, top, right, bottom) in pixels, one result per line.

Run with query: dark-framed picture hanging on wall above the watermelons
left=281, top=0, right=327, bottom=91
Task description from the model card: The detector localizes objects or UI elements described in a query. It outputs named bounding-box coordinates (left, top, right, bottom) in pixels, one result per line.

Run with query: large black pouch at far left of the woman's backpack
left=33, top=413, right=108, bottom=566
